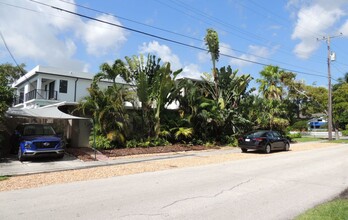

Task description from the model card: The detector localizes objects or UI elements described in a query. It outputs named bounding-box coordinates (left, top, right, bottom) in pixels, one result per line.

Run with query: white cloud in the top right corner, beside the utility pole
left=288, top=0, right=348, bottom=59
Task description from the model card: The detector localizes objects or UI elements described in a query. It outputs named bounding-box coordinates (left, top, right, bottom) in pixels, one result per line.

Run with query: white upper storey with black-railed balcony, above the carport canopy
left=13, top=66, right=126, bottom=108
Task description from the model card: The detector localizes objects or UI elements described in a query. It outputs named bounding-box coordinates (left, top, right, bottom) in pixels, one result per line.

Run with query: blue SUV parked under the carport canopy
left=12, top=123, right=65, bottom=161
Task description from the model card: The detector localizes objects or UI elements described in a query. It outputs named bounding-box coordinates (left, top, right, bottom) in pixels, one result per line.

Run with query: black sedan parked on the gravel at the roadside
left=238, top=130, right=290, bottom=154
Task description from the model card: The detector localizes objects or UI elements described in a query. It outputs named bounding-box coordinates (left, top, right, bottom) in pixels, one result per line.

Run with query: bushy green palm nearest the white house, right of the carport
left=77, top=61, right=131, bottom=147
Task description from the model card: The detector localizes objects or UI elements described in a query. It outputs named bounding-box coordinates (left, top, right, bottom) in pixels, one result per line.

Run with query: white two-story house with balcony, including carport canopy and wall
left=7, top=66, right=126, bottom=147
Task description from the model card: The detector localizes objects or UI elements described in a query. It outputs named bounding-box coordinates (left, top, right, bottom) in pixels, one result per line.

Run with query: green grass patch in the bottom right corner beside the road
left=295, top=199, right=348, bottom=220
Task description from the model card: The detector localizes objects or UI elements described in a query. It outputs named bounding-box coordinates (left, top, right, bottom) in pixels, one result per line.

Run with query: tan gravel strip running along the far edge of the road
left=0, top=142, right=337, bottom=191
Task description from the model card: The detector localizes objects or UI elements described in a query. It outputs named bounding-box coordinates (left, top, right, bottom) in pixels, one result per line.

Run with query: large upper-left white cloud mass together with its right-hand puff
left=0, top=0, right=126, bottom=71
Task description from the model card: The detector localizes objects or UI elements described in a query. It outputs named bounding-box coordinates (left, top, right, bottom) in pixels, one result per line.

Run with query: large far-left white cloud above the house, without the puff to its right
left=0, top=1, right=83, bottom=69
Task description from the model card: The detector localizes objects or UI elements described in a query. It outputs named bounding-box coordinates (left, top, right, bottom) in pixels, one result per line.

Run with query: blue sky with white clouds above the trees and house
left=0, top=0, right=348, bottom=87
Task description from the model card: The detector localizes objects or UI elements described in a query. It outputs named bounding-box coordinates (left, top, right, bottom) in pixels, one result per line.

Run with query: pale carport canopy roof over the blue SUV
left=6, top=106, right=89, bottom=119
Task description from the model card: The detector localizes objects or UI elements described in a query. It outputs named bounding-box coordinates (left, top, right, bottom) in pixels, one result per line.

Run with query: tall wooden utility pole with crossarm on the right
left=317, top=33, right=342, bottom=141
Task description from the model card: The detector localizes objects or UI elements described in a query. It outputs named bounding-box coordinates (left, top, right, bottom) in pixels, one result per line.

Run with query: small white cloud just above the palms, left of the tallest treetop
left=139, top=41, right=182, bottom=70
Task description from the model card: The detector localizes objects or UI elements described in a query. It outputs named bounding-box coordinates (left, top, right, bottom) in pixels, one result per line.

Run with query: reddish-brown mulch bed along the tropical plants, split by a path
left=66, top=144, right=219, bottom=161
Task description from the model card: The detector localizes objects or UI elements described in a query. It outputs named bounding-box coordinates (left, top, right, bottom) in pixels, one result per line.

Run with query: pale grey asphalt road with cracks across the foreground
left=0, top=145, right=348, bottom=220
